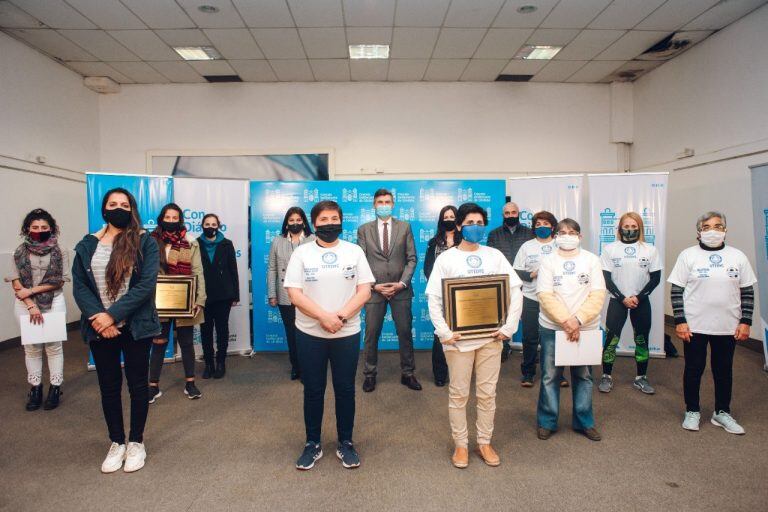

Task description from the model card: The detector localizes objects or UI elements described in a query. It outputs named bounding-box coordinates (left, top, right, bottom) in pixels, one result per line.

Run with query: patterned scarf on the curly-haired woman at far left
left=13, top=236, right=64, bottom=313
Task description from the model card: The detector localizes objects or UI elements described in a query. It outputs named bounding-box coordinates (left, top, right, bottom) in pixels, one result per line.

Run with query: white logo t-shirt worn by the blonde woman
left=600, top=240, right=663, bottom=297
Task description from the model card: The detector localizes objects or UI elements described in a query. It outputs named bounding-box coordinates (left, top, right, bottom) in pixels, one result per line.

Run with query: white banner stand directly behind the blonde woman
left=584, top=172, right=669, bottom=357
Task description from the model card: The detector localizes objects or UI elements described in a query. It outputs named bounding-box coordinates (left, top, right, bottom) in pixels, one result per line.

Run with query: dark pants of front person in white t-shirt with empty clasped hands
left=296, top=330, right=360, bottom=443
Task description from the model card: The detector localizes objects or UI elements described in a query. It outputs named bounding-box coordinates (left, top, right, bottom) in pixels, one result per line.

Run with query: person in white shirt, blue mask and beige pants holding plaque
left=426, top=203, right=522, bottom=468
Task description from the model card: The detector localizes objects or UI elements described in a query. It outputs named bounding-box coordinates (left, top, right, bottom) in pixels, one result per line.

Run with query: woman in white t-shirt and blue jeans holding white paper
left=536, top=219, right=605, bottom=441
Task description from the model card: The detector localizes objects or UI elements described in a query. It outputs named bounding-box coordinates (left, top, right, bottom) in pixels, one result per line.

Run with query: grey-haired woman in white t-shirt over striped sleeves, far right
left=667, top=212, right=757, bottom=434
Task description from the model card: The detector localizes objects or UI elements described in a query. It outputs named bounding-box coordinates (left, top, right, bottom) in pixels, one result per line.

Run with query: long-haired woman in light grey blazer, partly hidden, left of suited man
left=267, top=206, right=315, bottom=380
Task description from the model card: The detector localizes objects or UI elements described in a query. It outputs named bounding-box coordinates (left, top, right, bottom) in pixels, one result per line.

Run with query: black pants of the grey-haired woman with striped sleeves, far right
left=683, top=333, right=736, bottom=414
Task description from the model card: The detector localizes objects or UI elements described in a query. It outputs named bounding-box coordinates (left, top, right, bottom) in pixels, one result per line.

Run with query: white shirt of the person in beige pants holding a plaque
left=425, top=245, right=523, bottom=352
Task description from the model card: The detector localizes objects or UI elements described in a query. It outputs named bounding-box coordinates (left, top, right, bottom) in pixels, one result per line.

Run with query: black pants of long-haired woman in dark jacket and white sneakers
left=90, top=329, right=152, bottom=444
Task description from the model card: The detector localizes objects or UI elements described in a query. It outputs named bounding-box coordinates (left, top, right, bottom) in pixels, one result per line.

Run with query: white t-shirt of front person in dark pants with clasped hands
left=283, top=240, right=376, bottom=338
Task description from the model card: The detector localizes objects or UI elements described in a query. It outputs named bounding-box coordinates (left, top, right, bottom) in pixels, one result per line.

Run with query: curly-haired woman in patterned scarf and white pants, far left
left=5, top=208, right=69, bottom=411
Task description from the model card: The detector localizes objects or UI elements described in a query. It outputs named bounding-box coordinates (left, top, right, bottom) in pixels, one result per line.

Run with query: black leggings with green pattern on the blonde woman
left=603, top=298, right=651, bottom=376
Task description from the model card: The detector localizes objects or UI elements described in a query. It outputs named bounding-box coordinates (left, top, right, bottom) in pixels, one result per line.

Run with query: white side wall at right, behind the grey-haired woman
left=632, top=6, right=768, bottom=337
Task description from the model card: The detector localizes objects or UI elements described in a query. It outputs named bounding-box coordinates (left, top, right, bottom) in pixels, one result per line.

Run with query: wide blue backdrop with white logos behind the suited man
left=250, top=180, right=504, bottom=352
